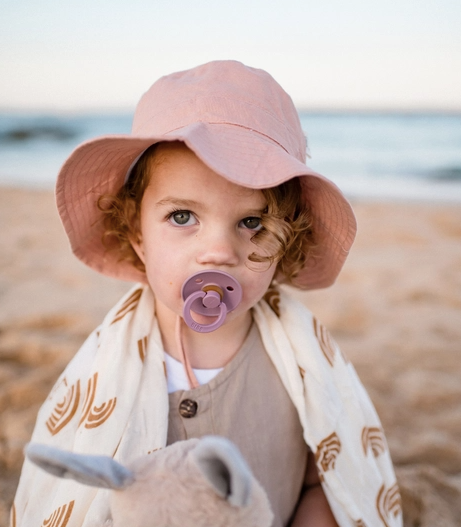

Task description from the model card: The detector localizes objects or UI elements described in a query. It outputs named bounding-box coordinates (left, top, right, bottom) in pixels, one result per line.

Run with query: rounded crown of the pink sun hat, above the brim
left=132, top=60, right=306, bottom=162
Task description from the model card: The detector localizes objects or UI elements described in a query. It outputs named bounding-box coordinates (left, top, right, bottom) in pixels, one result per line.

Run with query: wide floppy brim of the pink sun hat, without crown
left=56, top=122, right=356, bottom=289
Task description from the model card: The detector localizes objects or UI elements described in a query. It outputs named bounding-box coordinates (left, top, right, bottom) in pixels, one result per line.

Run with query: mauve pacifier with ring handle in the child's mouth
left=181, top=271, right=242, bottom=333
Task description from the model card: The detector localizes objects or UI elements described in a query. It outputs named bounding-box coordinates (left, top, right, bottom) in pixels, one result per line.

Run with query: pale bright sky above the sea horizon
left=0, top=0, right=461, bottom=112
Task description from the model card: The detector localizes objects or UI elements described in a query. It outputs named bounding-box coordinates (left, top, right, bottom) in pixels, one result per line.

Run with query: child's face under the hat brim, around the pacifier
left=133, top=144, right=276, bottom=323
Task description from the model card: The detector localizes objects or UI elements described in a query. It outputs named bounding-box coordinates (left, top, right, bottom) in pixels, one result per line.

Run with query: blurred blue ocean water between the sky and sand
left=0, top=112, right=461, bottom=202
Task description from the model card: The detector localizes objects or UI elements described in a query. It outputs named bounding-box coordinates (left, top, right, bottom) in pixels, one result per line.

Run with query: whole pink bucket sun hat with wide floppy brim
left=56, top=61, right=356, bottom=289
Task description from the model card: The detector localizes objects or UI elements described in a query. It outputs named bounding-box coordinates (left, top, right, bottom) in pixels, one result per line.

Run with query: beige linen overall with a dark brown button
left=168, top=324, right=308, bottom=527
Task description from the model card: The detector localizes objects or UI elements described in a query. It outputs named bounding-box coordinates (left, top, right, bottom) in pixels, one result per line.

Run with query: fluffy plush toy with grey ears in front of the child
left=26, top=436, right=273, bottom=527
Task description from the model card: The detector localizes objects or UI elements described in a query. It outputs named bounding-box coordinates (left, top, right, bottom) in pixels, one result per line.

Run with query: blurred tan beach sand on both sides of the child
left=0, top=188, right=461, bottom=527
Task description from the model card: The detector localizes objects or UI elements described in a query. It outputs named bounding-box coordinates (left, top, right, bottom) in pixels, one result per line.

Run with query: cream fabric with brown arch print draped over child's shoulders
left=11, top=285, right=402, bottom=527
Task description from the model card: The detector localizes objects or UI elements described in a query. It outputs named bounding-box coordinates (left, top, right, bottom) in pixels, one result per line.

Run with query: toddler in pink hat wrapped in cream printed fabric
left=12, top=61, right=402, bottom=527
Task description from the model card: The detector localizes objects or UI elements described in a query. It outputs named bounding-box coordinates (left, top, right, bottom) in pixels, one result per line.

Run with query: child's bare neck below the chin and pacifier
left=156, top=302, right=252, bottom=369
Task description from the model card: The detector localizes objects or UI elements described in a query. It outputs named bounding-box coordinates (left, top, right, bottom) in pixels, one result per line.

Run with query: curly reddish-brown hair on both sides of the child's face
left=97, top=144, right=315, bottom=283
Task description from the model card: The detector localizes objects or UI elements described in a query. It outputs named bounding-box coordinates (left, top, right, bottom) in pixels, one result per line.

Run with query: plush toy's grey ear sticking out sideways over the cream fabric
left=25, top=443, right=134, bottom=489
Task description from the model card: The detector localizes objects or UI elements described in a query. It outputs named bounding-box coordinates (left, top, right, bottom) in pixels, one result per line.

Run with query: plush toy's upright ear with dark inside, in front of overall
left=192, top=436, right=252, bottom=507
